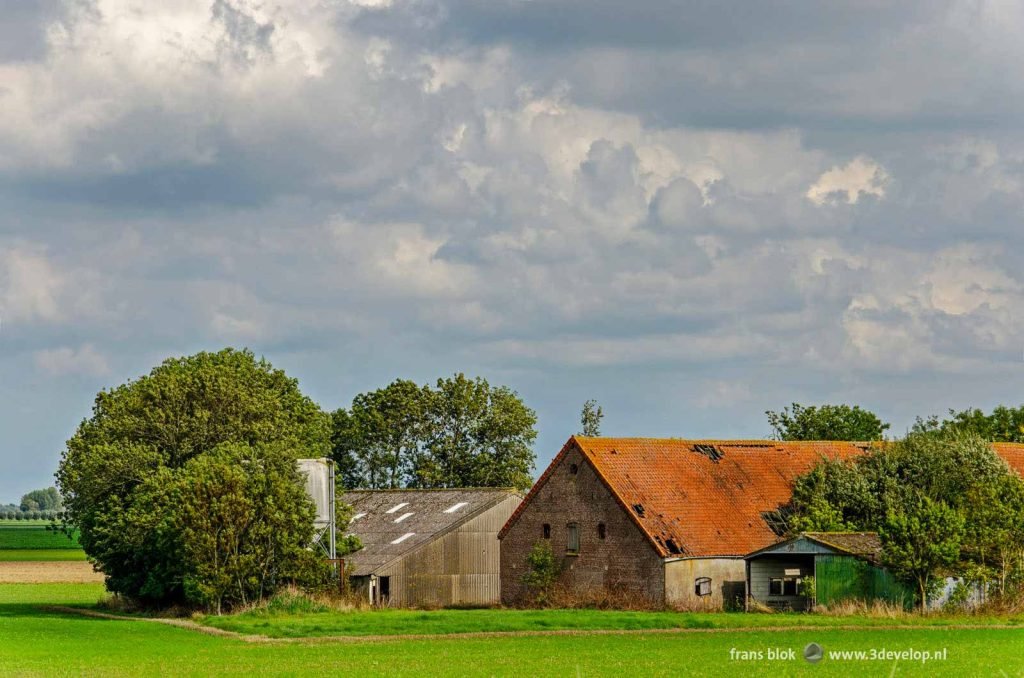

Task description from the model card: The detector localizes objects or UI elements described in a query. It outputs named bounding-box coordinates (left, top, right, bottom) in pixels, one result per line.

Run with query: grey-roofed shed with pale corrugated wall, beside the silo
left=340, top=489, right=522, bottom=606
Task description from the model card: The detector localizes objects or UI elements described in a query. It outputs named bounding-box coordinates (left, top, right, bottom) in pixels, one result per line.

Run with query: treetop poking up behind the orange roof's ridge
left=765, top=402, right=889, bottom=440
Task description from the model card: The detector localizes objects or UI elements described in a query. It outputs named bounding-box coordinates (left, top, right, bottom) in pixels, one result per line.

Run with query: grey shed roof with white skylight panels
left=340, top=488, right=521, bottom=576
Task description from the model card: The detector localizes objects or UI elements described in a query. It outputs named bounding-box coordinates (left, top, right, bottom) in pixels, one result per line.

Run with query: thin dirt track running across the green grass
left=39, top=606, right=1021, bottom=645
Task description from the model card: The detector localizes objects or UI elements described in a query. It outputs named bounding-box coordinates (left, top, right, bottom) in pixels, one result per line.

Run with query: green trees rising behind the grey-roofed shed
left=332, top=374, right=537, bottom=489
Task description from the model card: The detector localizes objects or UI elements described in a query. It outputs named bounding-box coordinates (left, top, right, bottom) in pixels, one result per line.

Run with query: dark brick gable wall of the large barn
left=502, top=450, right=665, bottom=605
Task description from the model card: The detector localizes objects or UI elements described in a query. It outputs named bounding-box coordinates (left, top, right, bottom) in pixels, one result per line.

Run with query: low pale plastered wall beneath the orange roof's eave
left=665, top=558, right=746, bottom=609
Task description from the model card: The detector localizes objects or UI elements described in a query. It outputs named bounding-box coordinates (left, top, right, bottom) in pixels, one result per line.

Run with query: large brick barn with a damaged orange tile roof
left=499, top=436, right=1024, bottom=608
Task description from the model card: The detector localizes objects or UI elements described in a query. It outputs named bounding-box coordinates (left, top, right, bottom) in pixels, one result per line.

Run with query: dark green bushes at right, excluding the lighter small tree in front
left=790, top=436, right=1024, bottom=610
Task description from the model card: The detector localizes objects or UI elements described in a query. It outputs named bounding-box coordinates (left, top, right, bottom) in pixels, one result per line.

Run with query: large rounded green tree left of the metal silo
left=57, top=349, right=330, bottom=604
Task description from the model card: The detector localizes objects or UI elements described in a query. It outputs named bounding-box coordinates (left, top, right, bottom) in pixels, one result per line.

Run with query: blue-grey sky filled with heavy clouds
left=0, top=0, right=1024, bottom=503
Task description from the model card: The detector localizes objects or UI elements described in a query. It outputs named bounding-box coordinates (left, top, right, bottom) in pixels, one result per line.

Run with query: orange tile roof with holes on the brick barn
left=500, top=436, right=1024, bottom=557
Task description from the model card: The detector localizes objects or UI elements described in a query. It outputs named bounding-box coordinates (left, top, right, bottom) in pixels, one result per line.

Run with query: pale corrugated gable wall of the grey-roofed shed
left=377, top=496, right=520, bottom=607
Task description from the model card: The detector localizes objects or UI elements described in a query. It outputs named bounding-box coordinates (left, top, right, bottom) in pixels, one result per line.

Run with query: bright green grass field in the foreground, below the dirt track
left=0, top=584, right=1024, bottom=678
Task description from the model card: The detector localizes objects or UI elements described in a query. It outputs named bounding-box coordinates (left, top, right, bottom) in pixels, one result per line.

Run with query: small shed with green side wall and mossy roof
left=745, top=533, right=914, bottom=610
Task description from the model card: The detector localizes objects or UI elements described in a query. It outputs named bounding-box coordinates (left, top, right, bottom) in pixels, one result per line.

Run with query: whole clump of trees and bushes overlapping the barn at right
left=788, top=430, right=1024, bottom=610
